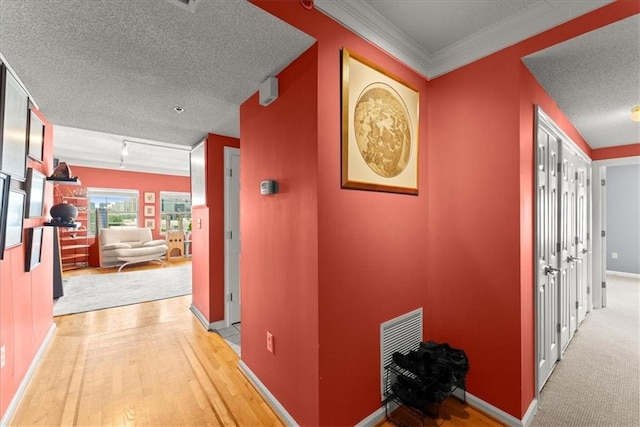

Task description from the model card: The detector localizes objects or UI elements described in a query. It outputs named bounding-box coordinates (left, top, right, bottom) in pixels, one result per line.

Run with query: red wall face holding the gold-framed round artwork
left=250, top=1, right=429, bottom=425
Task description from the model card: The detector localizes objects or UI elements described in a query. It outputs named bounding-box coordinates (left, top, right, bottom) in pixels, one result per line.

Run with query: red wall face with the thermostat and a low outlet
left=240, top=47, right=319, bottom=425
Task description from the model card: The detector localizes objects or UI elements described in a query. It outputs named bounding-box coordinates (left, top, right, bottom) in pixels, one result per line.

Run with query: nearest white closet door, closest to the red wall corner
left=536, top=125, right=559, bottom=390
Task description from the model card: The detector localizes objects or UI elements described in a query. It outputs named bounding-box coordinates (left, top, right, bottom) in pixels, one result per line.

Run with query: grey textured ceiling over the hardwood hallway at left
left=0, top=0, right=314, bottom=149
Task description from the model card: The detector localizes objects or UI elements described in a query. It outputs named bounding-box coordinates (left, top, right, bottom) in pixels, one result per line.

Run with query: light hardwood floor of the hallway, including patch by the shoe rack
left=10, top=286, right=501, bottom=427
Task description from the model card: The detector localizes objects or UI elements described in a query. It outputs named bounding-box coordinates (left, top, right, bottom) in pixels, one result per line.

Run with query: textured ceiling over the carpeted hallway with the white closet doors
left=524, top=15, right=640, bottom=148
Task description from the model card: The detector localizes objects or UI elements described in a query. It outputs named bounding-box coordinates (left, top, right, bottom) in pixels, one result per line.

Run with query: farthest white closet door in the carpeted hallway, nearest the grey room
left=575, top=158, right=589, bottom=325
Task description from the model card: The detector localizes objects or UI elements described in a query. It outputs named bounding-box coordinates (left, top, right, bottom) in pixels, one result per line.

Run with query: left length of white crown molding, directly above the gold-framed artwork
left=315, top=0, right=431, bottom=78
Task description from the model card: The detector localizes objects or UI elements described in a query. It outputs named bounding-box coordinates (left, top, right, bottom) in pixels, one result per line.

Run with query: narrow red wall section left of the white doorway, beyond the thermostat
left=191, top=134, right=244, bottom=323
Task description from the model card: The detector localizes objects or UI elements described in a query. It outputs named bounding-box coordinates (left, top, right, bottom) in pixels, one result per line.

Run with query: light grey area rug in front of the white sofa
left=53, top=265, right=191, bottom=316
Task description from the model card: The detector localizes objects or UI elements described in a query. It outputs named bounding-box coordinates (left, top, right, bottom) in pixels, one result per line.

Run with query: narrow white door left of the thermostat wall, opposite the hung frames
left=224, top=147, right=241, bottom=326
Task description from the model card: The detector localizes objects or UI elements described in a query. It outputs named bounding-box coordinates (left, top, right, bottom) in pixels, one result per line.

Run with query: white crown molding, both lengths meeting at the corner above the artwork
left=315, top=0, right=613, bottom=78
